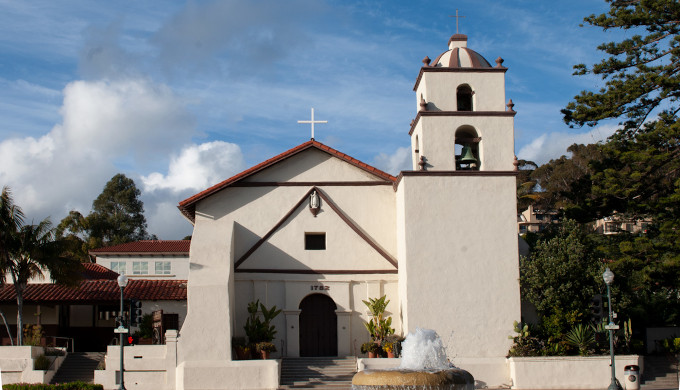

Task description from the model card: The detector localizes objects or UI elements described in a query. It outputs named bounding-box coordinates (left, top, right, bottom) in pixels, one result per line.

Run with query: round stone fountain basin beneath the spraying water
left=352, top=368, right=475, bottom=390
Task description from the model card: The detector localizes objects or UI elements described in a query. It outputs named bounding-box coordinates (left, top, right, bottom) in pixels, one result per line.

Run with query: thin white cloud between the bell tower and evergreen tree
left=517, top=125, right=617, bottom=165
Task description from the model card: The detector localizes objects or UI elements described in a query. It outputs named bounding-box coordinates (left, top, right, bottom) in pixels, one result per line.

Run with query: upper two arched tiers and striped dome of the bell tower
left=409, top=34, right=515, bottom=171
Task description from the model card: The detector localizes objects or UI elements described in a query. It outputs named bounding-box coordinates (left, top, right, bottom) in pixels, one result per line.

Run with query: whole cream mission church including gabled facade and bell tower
left=176, top=34, right=520, bottom=389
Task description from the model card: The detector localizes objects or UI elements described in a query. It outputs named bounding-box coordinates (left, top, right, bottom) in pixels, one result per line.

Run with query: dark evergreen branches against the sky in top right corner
left=562, top=0, right=680, bottom=133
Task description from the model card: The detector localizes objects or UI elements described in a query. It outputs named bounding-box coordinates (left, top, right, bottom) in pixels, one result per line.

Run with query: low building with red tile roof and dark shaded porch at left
left=0, top=262, right=187, bottom=351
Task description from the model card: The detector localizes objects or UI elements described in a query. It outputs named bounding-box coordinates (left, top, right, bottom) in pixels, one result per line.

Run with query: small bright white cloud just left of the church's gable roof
left=142, top=141, right=245, bottom=193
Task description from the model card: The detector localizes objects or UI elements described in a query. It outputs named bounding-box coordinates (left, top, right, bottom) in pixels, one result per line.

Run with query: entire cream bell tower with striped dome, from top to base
left=397, top=34, right=521, bottom=387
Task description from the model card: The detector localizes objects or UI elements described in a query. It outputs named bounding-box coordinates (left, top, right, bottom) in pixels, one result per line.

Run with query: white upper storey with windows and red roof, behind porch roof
left=89, top=240, right=191, bottom=280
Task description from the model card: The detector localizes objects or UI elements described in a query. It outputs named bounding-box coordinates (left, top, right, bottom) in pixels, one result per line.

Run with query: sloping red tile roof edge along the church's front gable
left=177, top=140, right=397, bottom=221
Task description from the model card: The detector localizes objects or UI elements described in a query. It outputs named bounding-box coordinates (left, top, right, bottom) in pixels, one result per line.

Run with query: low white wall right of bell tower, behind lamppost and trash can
left=508, top=355, right=644, bottom=389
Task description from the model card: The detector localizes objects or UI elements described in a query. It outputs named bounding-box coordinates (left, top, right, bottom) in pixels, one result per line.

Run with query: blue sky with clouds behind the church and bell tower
left=0, top=0, right=622, bottom=239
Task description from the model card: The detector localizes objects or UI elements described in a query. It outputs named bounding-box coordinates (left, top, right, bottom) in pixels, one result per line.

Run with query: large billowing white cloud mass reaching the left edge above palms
left=0, top=80, right=195, bottom=231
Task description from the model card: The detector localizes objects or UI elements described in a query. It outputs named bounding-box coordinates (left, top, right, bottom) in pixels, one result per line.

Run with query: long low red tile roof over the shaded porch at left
left=0, top=279, right=187, bottom=304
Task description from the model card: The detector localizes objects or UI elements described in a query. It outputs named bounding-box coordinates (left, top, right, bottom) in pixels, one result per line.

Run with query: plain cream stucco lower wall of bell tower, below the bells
left=398, top=175, right=520, bottom=380
